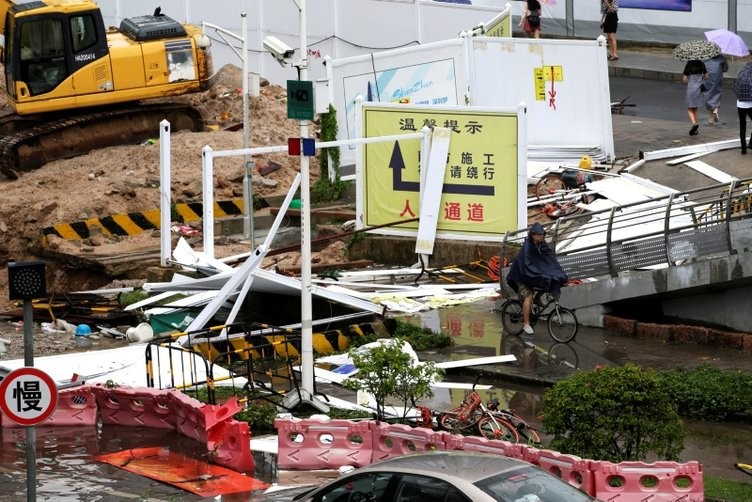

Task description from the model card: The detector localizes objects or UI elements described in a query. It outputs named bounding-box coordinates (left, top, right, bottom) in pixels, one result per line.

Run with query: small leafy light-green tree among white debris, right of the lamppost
left=343, top=338, right=444, bottom=421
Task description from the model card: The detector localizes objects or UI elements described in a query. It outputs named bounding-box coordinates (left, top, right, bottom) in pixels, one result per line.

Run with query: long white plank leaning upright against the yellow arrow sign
left=415, top=127, right=452, bottom=255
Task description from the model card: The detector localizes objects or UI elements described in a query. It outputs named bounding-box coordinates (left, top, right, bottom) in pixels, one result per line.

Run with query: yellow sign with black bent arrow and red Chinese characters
left=359, top=104, right=519, bottom=237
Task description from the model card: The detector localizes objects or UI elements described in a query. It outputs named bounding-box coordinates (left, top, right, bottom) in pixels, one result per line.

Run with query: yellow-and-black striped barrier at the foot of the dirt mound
left=40, top=199, right=243, bottom=247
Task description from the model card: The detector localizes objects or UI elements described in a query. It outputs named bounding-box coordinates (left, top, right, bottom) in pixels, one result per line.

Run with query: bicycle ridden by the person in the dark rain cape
left=501, top=290, right=579, bottom=343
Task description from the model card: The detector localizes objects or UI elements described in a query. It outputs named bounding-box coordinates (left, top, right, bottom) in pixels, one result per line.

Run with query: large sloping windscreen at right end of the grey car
left=475, top=465, right=595, bottom=502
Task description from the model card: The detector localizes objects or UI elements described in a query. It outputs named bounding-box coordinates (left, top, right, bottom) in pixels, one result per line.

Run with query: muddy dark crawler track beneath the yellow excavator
left=0, top=103, right=204, bottom=180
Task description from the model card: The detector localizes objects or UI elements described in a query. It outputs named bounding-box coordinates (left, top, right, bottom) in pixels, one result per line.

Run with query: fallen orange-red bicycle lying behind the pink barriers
left=439, top=389, right=520, bottom=443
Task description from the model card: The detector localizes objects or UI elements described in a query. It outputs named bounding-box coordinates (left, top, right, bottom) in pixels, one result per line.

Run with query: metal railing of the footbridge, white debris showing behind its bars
left=501, top=178, right=752, bottom=278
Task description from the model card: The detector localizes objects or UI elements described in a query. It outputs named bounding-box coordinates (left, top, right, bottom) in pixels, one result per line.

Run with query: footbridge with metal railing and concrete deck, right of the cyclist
left=501, top=178, right=752, bottom=332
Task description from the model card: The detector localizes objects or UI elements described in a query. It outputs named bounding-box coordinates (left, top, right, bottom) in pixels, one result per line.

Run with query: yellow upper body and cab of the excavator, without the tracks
left=0, top=0, right=212, bottom=115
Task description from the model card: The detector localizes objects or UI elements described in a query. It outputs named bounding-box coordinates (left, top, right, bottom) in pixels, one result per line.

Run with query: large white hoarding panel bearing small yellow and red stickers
left=470, top=37, right=614, bottom=160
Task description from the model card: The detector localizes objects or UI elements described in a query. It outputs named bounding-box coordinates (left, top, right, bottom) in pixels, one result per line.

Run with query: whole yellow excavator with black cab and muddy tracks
left=0, top=0, right=212, bottom=179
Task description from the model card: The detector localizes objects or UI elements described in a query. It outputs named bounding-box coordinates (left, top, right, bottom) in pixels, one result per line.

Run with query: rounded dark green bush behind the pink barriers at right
left=543, top=364, right=684, bottom=462
